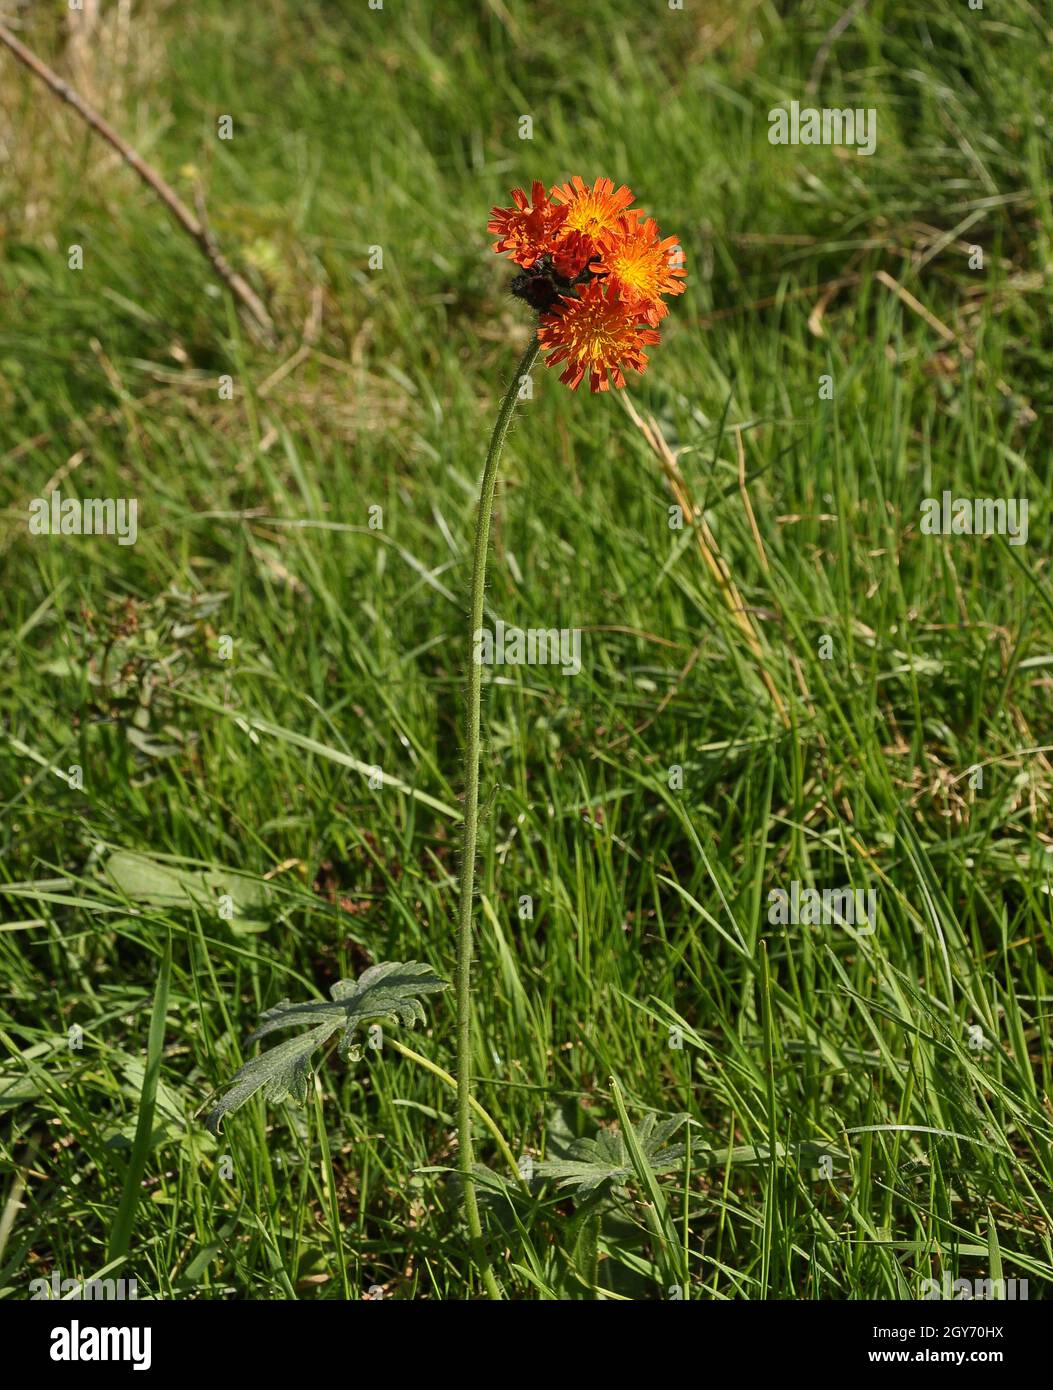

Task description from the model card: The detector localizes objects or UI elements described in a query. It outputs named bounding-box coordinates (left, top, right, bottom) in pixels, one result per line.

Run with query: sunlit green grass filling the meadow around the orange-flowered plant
left=0, top=0, right=1053, bottom=1300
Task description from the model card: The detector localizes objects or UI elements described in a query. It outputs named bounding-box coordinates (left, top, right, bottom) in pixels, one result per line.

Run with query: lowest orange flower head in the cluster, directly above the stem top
left=538, top=279, right=660, bottom=391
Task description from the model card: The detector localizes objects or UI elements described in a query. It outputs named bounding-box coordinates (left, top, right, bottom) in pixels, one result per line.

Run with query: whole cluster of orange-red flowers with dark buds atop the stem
left=486, top=175, right=688, bottom=391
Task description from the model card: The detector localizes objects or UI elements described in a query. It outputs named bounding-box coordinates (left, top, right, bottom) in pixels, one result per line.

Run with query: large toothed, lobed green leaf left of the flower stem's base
left=206, top=960, right=447, bottom=1134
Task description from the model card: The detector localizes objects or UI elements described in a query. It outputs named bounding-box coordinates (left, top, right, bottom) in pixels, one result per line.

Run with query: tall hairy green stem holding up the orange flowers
left=457, top=335, right=540, bottom=1298
